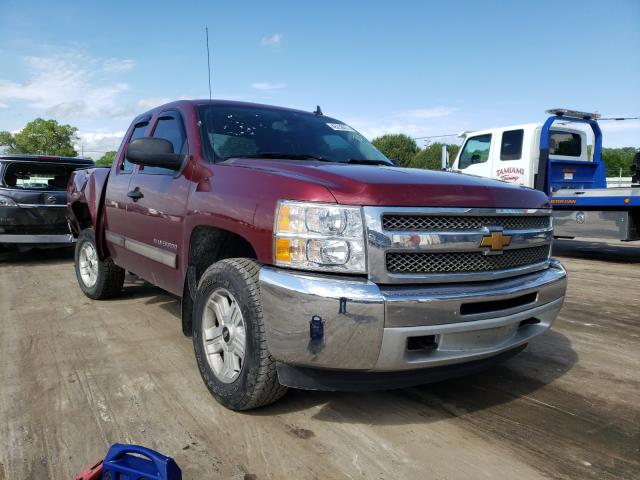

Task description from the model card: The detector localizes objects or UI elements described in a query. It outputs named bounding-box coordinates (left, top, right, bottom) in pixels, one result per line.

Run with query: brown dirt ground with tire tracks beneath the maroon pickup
left=0, top=242, right=640, bottom=480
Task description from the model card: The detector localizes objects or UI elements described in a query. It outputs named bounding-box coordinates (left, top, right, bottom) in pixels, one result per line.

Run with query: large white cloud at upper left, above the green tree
left=0, top=51, right=135, bottom=117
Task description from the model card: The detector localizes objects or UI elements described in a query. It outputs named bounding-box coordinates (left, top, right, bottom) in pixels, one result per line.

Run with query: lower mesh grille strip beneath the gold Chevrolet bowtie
left=386, top=245, right=551, bottom=273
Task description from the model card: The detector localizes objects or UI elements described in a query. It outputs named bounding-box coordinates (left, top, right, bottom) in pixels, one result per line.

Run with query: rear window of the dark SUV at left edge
left=2, top=162, right=76, bottom=191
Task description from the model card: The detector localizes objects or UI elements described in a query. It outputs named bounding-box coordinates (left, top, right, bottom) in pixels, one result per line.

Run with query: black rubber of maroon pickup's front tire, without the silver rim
left=193, top=258, right=287, bottom=410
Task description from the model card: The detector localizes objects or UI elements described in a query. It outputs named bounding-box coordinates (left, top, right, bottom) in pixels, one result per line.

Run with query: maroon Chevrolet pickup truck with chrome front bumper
left=67, top=100, right=566, bottom=410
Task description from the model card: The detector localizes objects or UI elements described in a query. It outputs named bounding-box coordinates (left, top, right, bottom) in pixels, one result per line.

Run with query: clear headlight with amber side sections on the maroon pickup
left=273, top=200, right=367, bottom=273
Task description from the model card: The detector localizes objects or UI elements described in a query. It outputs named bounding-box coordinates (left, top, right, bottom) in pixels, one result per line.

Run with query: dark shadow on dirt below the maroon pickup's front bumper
left=248, top=331, right=578, bottom=425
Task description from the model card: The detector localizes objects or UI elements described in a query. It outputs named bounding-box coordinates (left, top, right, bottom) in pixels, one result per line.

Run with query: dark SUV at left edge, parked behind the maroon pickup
left=0, top=155, right=94, bottom=249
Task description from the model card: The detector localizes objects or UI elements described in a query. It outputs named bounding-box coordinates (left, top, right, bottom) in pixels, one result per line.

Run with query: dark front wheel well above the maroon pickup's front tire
left=182, top=226, right=257, bottom=335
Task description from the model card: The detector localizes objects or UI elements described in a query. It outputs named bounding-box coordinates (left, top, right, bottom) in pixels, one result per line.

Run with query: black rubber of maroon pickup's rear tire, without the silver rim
left=75, top=228, right=125, bottom=300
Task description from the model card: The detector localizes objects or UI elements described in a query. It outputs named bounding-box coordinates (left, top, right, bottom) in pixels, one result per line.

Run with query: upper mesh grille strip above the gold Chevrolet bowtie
left=382, top=215, right=551, bottom=231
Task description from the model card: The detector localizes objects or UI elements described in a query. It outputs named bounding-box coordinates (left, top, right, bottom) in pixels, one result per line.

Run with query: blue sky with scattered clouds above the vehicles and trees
left=0, top=0, right=640, bottom=158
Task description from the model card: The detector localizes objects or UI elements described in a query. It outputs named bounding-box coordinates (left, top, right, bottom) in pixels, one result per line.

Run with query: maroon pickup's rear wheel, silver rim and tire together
left=75, top=228, right=125, bottom=300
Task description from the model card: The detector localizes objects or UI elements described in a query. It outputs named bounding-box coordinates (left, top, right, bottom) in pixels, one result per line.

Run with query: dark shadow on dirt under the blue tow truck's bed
left=553, top=240, right=640, bottom=263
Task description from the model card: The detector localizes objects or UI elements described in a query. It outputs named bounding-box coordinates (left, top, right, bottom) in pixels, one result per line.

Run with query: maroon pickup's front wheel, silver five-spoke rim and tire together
left=193, top=258, right=287, bottom=410
